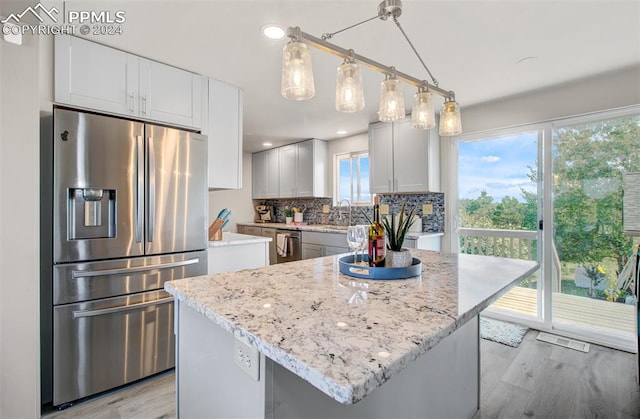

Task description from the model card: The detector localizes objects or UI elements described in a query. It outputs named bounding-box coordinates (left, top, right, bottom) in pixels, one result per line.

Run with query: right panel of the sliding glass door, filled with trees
left=550, top=115, right=640, bottom=349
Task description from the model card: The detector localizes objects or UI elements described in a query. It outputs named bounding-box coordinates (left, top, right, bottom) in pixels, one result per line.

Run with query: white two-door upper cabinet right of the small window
left=369, top=118, right=440, bottom=193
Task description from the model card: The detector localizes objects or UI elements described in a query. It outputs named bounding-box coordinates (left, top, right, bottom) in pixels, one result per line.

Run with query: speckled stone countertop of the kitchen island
left=165, top=250, right=538, bottom=404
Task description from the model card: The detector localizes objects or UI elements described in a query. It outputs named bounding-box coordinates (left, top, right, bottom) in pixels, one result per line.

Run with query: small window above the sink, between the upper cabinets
left=334, top=151, right=371, bottom=205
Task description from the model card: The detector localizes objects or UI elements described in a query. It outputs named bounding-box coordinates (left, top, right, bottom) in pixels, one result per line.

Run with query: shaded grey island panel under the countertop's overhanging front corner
left=265, top=316, right=480, bottom=419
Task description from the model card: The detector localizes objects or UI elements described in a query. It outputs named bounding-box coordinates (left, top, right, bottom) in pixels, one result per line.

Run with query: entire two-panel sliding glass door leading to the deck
left=452, top=107, right=640, bottom=351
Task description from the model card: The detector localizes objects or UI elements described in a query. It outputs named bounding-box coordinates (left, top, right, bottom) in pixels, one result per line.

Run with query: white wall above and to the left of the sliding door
left=440, top=66, right=640, bottom=251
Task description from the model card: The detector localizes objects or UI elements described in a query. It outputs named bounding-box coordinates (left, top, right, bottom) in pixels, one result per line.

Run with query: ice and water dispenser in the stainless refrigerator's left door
left=68, top=188, right=116, bottom=240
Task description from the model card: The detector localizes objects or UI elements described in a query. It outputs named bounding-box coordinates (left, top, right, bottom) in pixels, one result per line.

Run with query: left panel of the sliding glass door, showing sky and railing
left=457, top=129, right=543, bottom=321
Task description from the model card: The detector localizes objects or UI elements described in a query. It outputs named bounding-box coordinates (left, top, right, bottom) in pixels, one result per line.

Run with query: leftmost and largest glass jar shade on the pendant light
left=280, top=42, right=316, bottom=100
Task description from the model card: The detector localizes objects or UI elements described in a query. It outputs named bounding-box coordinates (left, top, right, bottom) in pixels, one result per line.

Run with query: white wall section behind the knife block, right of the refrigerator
left=209, top=153, right=254, bottom=232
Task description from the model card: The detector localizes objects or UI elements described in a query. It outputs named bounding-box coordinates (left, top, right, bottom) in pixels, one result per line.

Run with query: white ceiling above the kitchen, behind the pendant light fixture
left=65, top=0, right=640, bottom=151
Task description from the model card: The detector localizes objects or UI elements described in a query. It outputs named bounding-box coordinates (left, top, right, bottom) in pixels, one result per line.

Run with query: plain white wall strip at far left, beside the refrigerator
left=0, top=9, right=40, bottom=418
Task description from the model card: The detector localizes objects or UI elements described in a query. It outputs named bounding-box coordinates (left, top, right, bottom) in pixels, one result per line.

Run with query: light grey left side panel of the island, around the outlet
left=176, top=300, right=266, bottom=419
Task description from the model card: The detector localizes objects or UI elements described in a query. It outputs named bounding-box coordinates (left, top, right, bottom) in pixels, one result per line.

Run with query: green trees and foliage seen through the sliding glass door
left=459, top=116, right=640, bottom=300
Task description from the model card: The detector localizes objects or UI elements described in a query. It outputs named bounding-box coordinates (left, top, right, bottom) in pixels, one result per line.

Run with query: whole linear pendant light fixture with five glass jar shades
left=282, top=0, right=462, bottom=136
